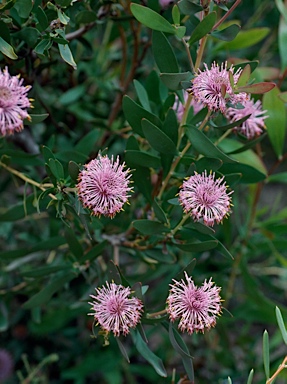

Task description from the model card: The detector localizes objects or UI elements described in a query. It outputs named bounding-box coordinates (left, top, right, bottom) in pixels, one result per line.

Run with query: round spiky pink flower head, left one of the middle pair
left=77, top=154, right=132, bottom=218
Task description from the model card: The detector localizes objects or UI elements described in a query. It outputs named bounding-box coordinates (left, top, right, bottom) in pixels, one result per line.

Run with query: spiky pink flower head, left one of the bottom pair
left=89, top=282, right=143, bottom=336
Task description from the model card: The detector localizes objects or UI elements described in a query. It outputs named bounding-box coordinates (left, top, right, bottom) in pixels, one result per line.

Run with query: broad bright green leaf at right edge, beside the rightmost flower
left=263, top=87, right=287, bottom=158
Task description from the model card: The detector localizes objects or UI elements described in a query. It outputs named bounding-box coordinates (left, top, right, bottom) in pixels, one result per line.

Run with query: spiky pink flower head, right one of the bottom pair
left=167, top=272, right=221, bottom=335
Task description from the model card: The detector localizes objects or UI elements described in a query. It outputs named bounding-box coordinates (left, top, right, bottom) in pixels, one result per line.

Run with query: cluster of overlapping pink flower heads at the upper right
left=174, top=63, right=268, bottom=139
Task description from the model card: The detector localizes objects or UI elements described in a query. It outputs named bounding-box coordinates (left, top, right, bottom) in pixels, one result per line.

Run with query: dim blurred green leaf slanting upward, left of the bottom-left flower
left=22, top=272, right=76, bottom=309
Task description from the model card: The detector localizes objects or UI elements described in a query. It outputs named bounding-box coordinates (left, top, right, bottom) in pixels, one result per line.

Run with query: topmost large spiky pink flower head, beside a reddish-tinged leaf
left=191, top=62, right=247, bottom=113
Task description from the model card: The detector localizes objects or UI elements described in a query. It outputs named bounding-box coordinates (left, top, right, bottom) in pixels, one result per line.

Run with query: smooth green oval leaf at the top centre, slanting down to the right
left=130, top=3, right=176, bottom=35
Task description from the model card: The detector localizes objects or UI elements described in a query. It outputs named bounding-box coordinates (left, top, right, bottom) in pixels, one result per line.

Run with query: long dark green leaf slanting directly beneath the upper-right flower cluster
left=186, top=125, right=236, bottom=163
